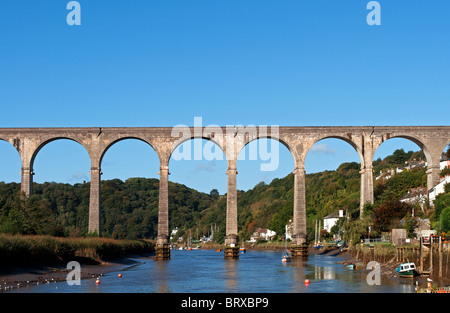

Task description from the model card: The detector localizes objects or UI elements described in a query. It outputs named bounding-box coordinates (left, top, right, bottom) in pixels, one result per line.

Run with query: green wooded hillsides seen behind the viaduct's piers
left=0, top=149, right=450, bottom=242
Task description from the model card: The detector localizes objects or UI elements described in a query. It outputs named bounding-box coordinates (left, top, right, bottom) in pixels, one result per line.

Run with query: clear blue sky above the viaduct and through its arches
left=0, top=0, right=450, bottom=193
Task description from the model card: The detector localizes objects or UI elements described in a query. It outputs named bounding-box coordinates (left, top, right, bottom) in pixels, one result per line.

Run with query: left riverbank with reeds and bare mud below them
left=0, top=234, right=155, bottom=291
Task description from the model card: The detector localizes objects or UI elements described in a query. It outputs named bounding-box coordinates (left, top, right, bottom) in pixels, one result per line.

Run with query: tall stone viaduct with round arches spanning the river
left=0, top=126, right=450, bottom=258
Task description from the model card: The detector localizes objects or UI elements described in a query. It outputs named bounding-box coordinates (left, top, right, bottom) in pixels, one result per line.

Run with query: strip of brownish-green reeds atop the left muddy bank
left=0, top=234, right=154, bottom=266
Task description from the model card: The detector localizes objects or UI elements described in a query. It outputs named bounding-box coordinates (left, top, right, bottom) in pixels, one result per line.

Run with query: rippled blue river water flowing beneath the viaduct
left=7, top=250, right=414, bottom=293
